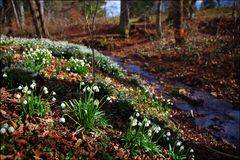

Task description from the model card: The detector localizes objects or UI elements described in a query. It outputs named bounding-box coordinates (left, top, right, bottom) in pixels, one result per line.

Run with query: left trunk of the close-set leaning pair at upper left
left=29, top=0, right=48, bottom=38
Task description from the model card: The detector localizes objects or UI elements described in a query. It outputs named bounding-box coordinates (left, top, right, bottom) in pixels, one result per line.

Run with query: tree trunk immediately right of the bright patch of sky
left=119, top=0, right=129, bottom=37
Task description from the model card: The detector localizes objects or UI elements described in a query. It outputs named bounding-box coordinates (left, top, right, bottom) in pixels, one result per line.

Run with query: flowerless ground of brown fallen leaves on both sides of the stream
left=54, top=15, right=240, bottom=159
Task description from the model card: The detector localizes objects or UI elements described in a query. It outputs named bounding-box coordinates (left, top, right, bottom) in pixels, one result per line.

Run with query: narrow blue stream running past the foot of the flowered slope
left=112, top=58, right=240, bottom=147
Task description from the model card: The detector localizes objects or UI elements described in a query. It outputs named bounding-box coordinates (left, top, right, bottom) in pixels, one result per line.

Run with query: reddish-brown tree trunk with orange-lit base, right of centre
left=172, top=0, right=185, bottom=44
